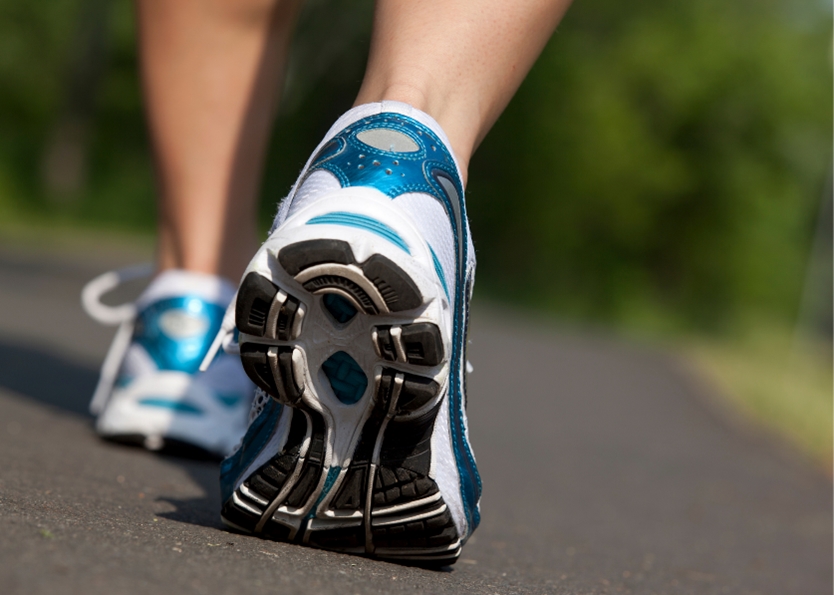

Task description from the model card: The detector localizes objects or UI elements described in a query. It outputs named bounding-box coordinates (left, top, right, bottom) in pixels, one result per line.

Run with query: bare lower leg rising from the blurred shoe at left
left=137, top=0, right=300, bottom=281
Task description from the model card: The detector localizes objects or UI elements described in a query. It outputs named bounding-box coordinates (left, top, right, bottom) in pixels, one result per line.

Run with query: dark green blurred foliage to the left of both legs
left=0, top=0, right=155, bottom=230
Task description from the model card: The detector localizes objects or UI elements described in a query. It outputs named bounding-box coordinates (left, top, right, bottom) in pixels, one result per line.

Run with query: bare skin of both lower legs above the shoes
left=136, top=0, right=570, bottom=281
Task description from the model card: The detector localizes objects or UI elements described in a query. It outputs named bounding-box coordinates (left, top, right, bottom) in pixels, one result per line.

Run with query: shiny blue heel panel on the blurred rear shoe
left=133, top=296, right=225, bottom=374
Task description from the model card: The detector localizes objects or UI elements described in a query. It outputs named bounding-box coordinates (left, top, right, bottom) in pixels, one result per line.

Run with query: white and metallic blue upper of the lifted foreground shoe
left=228, top=102, right=481, bottom=538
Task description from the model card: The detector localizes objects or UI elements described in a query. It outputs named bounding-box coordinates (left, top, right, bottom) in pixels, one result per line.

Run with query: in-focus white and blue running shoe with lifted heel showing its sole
left=210, top=102, right=481, bottom=566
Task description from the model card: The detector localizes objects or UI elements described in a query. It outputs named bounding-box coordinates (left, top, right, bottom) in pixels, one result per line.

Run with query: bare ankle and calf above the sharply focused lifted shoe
left=356, top=0, right=570, bottom=182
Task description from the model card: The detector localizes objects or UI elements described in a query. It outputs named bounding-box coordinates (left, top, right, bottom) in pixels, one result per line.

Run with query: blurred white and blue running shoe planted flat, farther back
left=82, top=266, right=255, bottom=458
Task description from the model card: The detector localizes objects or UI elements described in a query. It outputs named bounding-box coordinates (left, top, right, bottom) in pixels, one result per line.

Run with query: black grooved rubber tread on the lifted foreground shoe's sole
left=228, top=240, right=460, bottom=565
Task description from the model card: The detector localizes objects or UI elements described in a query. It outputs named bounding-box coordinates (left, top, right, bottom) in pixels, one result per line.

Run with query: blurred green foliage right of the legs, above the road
left=469, top=0, right=831, bottom=330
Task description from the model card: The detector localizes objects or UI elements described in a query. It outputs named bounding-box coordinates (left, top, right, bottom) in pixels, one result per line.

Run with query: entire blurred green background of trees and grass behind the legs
left=0, top=0, right=832, bottom=461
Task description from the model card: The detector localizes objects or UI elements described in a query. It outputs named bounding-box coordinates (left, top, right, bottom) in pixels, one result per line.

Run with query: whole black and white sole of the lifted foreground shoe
left=222, top=239, right=461, bottom=566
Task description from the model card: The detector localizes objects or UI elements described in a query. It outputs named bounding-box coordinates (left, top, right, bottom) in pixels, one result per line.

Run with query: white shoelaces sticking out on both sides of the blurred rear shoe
left=81, top=263, right=240, bottom=415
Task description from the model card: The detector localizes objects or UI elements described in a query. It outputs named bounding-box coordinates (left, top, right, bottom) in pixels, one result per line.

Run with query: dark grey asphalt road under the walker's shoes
left=0, top=235, right=832, bottom=595
